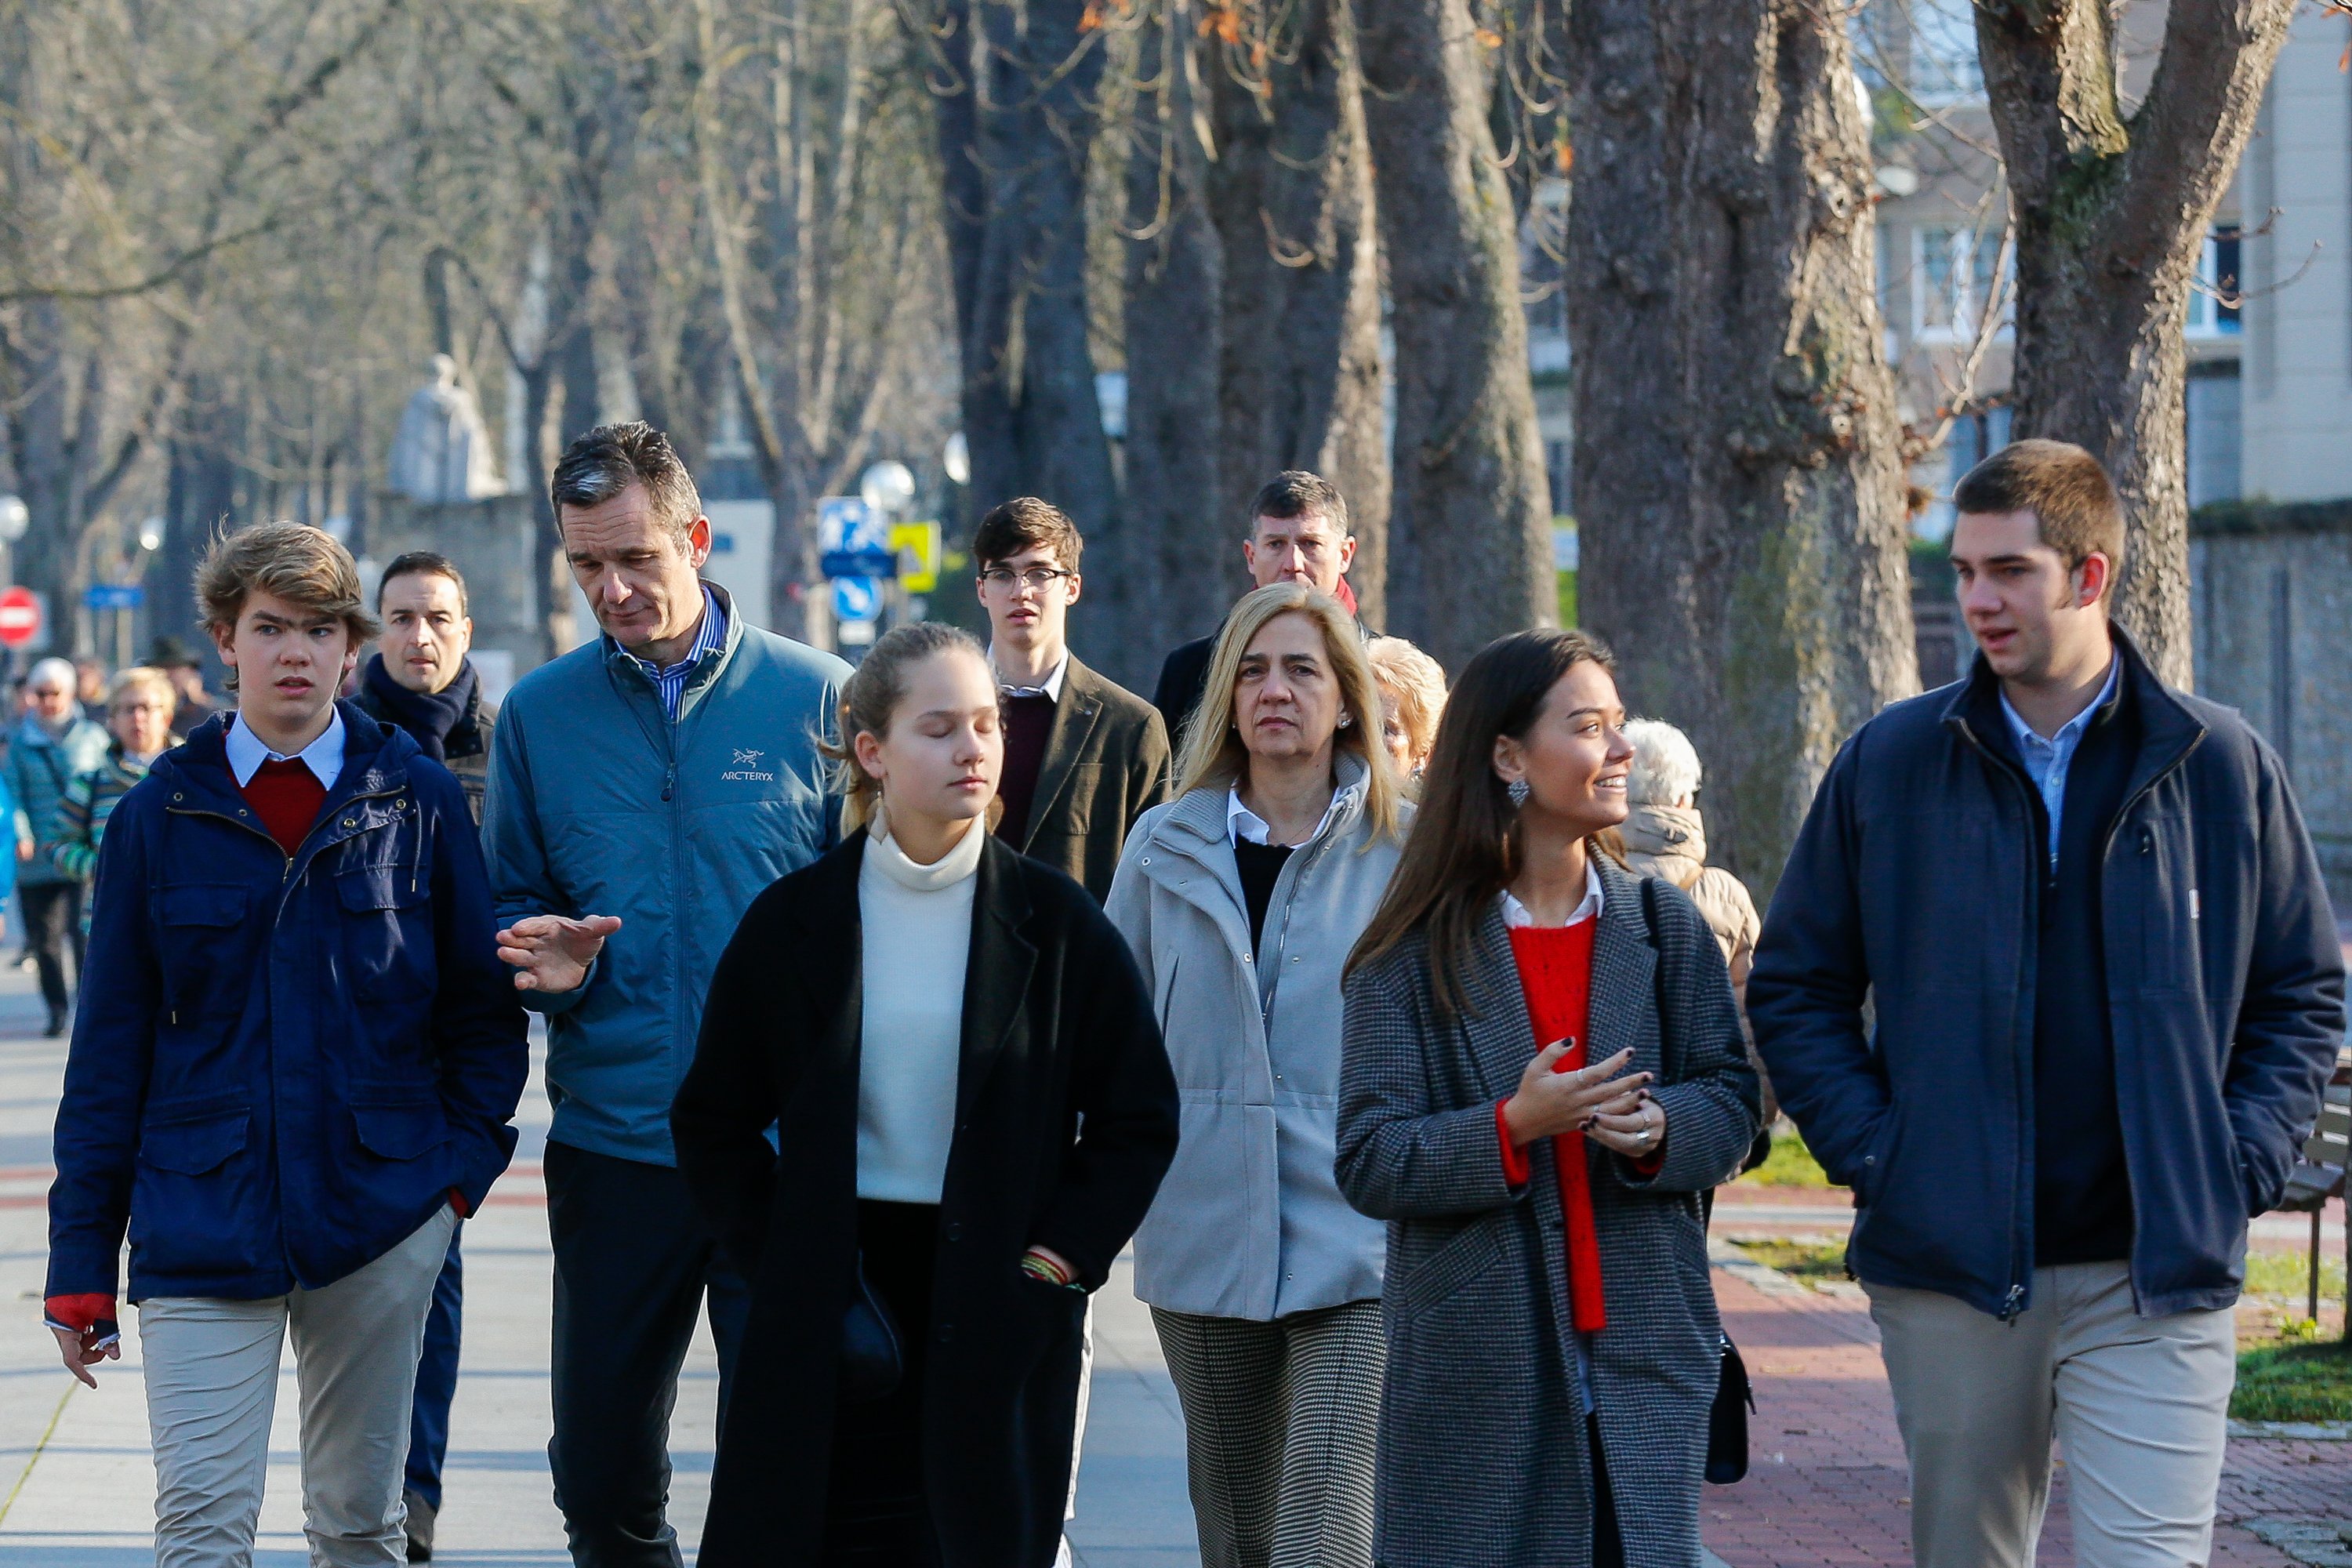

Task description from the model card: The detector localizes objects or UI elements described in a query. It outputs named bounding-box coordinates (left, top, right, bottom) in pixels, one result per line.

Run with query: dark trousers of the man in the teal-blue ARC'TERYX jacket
left=546, top=1142, right=750, bottom=1568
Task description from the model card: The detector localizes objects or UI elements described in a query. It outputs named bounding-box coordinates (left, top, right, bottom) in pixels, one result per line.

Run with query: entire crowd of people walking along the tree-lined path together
left=32, top=423, right=2345, bottom=1568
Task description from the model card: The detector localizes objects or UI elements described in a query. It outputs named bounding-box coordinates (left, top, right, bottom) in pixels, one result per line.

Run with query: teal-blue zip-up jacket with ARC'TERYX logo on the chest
left=482, top=586, right=849, bottom=1166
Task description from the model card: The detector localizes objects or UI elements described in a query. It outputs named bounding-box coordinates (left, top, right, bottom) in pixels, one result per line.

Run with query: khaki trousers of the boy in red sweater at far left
left=139, top=1206, right=456, bottom=1568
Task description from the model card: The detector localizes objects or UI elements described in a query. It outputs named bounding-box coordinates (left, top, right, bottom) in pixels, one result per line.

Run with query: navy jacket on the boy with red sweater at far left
left=47, top=703, right=529, bottom=1300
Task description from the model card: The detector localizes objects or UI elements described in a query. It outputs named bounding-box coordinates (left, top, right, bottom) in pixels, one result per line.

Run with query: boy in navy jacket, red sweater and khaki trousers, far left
left=47, top=524, right=527, bottom=1568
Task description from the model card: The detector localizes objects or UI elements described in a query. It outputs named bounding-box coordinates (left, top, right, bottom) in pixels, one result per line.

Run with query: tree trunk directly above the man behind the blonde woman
left=1190, top=0, right=1390, bottom=637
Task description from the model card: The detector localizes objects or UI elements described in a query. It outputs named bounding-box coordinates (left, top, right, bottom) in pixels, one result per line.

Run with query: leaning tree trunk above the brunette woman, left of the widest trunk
left=1355, top=0, right=1559, bottom=673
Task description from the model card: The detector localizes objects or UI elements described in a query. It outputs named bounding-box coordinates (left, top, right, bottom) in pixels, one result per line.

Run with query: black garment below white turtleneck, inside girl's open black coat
left=818, top=1199, right=941, bottom=1568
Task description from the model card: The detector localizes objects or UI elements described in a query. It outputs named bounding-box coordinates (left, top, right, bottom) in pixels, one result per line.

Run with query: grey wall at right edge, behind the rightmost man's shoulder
left=2190, top=499, right=2352, bottom=909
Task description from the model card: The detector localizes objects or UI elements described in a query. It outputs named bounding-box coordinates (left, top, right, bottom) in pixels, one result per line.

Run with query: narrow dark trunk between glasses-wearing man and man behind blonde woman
left=1115, top=0, right=1240, bottom=691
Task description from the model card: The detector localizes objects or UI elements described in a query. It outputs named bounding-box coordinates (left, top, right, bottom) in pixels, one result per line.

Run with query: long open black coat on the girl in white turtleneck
left=670, top=832, right=1176, bottom=1568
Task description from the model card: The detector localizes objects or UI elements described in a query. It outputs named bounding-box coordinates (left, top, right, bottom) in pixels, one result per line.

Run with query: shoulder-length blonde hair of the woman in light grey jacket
left=1176, top=583, right=1402, bottom=839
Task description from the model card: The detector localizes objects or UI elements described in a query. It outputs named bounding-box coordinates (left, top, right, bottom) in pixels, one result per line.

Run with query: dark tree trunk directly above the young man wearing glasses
left=938, top=0, right=1117, bottom=534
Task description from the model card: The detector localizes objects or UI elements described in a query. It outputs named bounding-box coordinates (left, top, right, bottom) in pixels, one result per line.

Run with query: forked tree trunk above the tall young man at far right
left=1976, top=0, right=2293, bottom=687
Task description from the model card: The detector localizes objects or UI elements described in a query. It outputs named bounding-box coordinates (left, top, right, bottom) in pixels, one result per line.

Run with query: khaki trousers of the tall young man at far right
left=1865, top=1262, right=2237, bottom=1568
